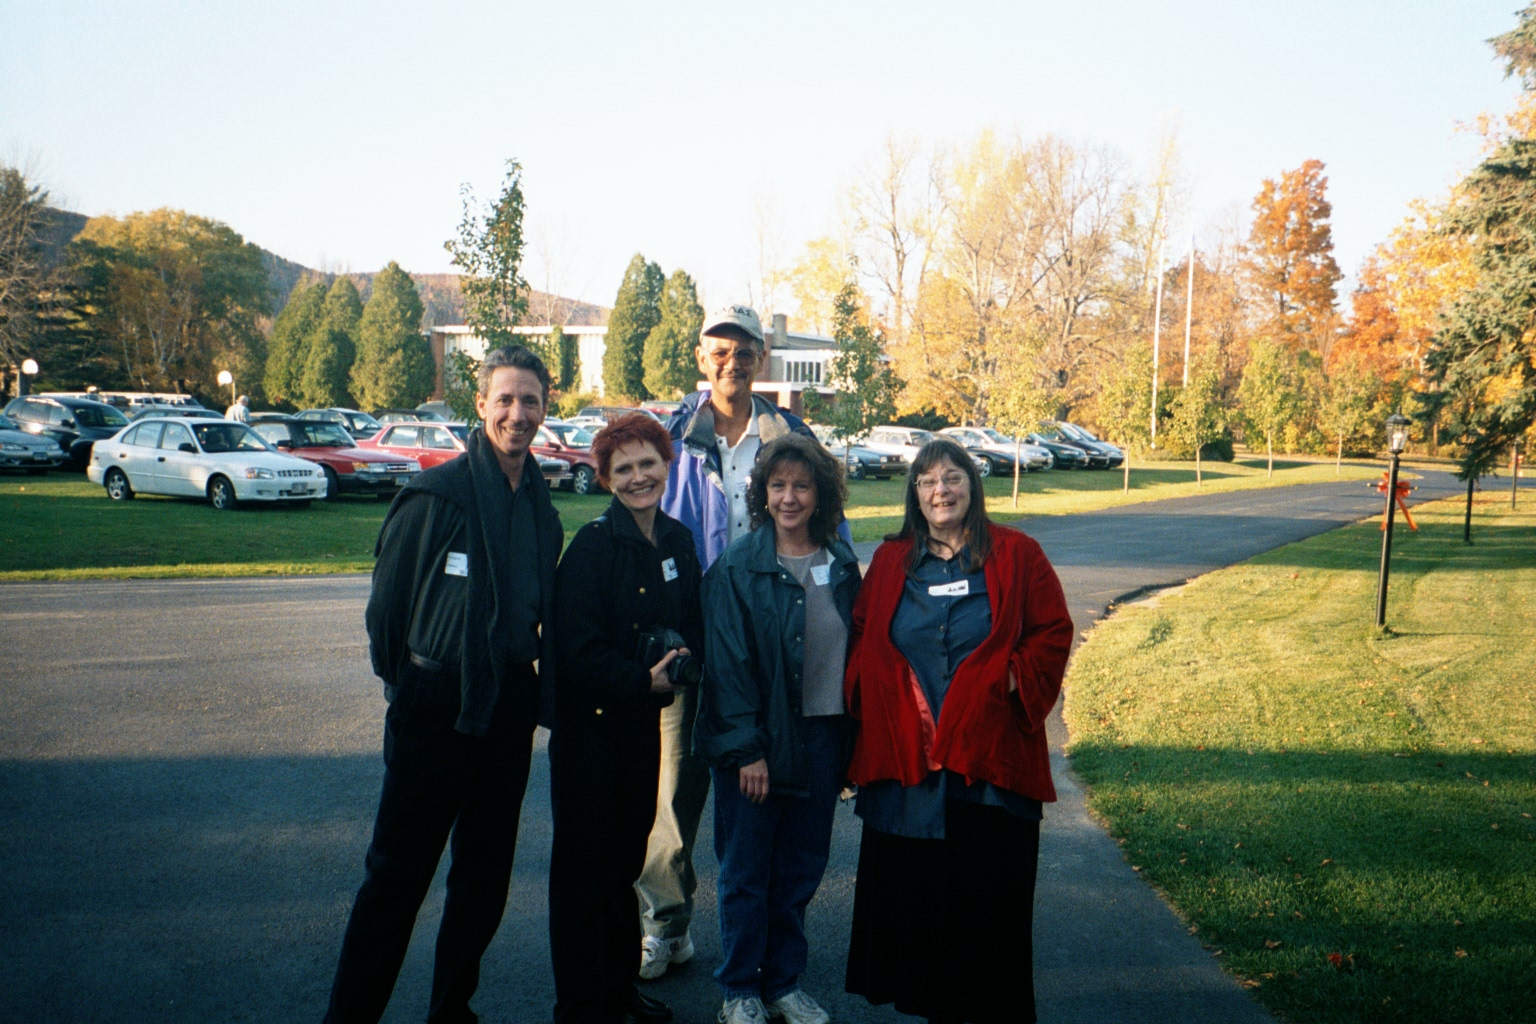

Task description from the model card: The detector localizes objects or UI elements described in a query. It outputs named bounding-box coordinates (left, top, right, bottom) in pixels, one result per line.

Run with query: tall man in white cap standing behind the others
left=636, top=306, right=848, bottom=979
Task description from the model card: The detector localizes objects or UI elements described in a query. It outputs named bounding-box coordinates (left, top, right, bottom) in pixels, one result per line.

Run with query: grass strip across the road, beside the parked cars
left=0, top=459, right=1381, bottom=580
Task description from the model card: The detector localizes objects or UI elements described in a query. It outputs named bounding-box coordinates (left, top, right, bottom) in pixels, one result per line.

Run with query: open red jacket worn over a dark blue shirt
left=843, top=525, right=1072, bottom=801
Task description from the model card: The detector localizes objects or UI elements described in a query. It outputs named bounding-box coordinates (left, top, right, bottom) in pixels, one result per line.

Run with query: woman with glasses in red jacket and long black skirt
left=845, top=439, right=1072, bottom=1024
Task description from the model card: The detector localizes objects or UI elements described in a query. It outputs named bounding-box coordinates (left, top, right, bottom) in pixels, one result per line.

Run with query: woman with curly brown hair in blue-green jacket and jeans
left=693, top=434, right=859, bottom=1024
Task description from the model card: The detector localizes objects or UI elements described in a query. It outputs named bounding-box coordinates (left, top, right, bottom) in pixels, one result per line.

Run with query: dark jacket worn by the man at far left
left=364, top=430, right=565, bottom=735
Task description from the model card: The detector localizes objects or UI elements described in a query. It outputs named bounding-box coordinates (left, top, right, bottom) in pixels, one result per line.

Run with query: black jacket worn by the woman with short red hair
left=554, top=497, right=703, bottom=728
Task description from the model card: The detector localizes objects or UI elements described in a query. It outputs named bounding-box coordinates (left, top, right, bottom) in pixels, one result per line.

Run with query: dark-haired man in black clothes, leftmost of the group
left=326, top=347, right=564, bottom=1024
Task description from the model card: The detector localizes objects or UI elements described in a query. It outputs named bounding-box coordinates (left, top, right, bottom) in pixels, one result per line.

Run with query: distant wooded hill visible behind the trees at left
left=45, top=207, right=610, bottom=329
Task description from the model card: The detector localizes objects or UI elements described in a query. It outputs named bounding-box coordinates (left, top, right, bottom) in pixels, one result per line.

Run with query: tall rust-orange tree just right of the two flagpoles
left=1249, top=160, right=1342, bottom=359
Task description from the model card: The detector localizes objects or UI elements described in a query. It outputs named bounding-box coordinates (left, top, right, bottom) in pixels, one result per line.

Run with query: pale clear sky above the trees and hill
left=0, top=0, right=1519, bottom=313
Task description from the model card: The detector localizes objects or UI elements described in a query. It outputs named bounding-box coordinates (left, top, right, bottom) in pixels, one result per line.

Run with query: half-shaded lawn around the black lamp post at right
left=1066, top=494, right=1536, bottom=1024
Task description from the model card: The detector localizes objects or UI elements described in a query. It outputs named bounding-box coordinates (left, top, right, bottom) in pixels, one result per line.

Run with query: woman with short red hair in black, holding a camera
left=550, top=413, right=703, bottom=1024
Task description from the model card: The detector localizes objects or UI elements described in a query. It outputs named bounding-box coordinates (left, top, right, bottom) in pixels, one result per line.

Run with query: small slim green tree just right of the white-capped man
left=805, top=281, right=902, bottom=457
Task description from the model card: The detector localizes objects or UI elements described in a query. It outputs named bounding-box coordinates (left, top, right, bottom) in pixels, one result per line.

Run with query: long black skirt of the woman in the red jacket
left=846, top=801, right=1040, bottom=1024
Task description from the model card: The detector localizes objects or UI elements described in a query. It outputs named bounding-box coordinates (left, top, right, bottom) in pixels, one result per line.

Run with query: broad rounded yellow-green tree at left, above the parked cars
left=71, top=209, right=270, bottom=393
